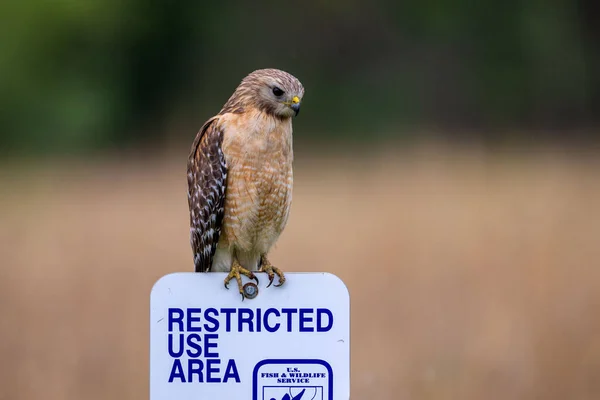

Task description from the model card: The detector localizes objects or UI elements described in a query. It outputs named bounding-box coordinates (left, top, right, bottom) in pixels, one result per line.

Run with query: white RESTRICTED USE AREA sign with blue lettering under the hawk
left=150, top=272, right=350, bottom=400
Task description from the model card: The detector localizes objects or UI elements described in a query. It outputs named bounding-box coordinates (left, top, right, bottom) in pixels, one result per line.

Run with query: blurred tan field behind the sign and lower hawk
left=0, top=146, right=600, bottom=400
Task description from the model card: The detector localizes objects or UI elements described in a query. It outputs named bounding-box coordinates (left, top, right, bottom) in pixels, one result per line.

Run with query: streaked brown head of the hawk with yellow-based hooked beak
left=230, top=69, right=304, bottom=118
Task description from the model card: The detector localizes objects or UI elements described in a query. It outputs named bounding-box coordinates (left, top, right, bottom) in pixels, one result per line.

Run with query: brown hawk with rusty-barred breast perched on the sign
left=187, top=69, right=304, bottom=299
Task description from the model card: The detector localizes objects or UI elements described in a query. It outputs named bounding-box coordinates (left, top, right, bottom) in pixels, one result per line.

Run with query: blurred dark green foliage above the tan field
left=0, top=0, right=600, bottom=152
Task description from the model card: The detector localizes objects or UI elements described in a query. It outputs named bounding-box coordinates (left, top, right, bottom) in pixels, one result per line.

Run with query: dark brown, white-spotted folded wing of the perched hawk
left=187, top=117, right=227, bottom=272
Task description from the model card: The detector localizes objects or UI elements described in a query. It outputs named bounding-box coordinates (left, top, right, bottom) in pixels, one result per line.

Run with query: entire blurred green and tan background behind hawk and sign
left=0, top=0, right=600, bottom=400
